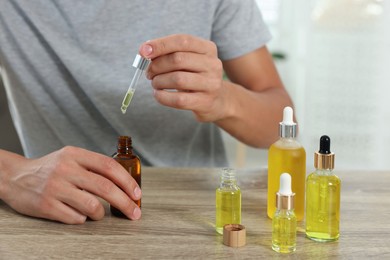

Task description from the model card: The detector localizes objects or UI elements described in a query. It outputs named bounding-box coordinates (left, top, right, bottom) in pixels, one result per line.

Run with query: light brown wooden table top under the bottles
left=0, top=168, right=390, bottom=259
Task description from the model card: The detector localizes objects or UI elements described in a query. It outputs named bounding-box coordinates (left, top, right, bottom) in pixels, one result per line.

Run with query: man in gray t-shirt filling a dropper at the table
left=0, top=0, right=291, bottom=224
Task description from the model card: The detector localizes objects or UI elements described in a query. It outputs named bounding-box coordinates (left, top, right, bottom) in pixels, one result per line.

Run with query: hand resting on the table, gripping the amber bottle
left=0, top=147, right=141, bottom=224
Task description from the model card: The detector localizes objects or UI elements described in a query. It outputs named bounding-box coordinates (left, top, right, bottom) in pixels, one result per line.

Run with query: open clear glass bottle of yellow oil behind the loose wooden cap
left=215, top=168, right=241, bottom=234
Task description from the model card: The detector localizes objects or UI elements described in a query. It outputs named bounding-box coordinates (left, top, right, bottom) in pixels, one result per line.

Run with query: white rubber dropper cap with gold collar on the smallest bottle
left=276, top=173, right=295, bottom=210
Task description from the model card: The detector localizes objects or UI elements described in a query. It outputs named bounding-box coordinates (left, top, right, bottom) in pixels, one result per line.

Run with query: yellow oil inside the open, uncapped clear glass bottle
left=215, top=186, right=241, bottom=234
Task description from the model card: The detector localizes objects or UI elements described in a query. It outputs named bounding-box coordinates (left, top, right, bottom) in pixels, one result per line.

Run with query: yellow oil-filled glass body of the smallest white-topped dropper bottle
left=272, top=210, right=297, bottom=253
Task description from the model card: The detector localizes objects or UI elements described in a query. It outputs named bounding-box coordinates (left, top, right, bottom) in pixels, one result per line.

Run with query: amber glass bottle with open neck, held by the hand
left=110, top=136, right=141, bottom=217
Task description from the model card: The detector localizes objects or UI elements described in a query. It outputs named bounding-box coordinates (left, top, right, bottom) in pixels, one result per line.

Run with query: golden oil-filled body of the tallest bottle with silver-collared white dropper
left=267, top=138, right=306, bottom=221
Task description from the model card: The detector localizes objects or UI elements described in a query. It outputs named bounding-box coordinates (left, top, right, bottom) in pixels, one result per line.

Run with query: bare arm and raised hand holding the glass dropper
left=139, top=34, right=293, bottom=148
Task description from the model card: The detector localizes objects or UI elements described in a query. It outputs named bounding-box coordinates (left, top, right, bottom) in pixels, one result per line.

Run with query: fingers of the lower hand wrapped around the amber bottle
left=53, top=147, right=142, bottom=220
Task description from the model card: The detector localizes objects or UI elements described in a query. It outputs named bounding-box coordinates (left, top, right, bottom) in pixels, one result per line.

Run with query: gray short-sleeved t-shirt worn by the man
left=0, top=0, right=270, bottom=167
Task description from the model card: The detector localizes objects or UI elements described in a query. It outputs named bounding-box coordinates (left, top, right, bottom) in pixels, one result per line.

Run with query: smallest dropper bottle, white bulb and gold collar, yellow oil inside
left=272, top=173, right=297, bottom=253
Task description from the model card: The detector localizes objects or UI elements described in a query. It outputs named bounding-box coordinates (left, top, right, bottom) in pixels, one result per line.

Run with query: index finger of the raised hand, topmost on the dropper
left=139, top=34, right=217, bottom=59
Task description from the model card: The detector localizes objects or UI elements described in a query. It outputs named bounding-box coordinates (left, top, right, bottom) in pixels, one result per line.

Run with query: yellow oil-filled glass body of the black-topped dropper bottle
left=306, top=171, right=341, bottom=242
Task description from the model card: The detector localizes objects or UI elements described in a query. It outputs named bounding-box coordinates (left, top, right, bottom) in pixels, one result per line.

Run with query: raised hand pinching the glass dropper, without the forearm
left=139, top=34, right=227, bottom=122
